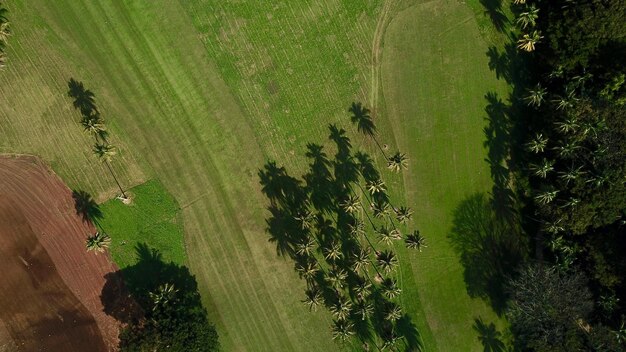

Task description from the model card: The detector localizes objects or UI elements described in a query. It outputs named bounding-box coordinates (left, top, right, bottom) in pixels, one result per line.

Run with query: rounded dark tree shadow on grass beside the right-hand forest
left=448, top=193, right=527, bottom=315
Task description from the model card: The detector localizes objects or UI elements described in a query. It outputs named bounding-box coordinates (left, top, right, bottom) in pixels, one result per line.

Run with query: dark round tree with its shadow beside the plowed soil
left=100, top=243, right=219, bottom=351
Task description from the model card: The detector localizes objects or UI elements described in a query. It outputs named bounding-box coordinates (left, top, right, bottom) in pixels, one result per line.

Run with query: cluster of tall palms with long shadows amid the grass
left=259, top=104, right=425, bottom=350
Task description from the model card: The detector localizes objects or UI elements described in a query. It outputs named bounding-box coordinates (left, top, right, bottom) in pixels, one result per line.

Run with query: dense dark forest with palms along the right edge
left=507, top=0, right=626, bottom=351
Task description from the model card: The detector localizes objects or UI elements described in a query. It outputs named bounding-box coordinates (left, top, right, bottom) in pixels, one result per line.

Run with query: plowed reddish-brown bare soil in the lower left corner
left=0, top=156, right=119, bottom=352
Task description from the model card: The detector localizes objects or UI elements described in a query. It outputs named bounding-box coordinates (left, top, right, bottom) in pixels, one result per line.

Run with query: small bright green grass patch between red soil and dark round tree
left=100, top=180, right=187, bottom=269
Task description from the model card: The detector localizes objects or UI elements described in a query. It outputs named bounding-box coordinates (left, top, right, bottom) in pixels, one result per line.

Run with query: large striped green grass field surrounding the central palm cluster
left=0, top=0, right=505, bottom=351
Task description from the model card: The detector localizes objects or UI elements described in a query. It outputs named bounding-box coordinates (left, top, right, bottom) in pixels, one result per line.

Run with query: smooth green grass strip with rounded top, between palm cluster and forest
left=382, top=0, right=507, bottom=351
